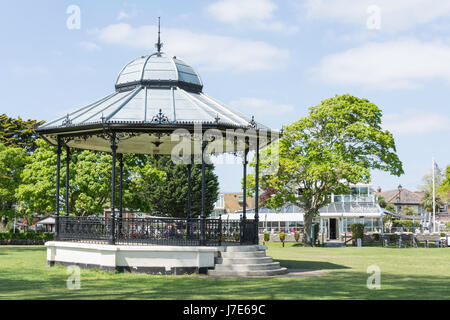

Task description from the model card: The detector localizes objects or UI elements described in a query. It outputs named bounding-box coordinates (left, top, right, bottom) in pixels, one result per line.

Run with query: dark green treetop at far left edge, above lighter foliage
left=0, top=114, right=44, bottom=152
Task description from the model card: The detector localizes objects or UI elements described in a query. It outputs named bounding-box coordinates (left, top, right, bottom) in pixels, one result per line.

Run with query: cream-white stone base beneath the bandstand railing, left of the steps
left=45, top=241, right=223, bottom=275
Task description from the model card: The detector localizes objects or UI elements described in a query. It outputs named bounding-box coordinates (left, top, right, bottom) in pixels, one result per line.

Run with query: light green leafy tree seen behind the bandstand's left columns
left=17, top=139, right=167, bottom=216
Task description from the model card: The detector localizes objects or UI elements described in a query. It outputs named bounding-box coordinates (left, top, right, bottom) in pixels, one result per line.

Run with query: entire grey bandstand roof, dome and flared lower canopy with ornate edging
left=37, top=39, right=276, bottom=154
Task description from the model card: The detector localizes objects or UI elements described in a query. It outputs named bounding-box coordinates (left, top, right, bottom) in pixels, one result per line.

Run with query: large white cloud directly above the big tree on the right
left=311, top=39, right=450, bottom=90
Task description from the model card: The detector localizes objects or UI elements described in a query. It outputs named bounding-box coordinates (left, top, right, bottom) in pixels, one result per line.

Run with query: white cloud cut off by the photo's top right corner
left=302, top=0, right=450, bottom=32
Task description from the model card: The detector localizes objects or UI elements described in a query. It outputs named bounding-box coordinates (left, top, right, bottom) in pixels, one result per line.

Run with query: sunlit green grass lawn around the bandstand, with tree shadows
left=0, top=243, right=450, bottom=300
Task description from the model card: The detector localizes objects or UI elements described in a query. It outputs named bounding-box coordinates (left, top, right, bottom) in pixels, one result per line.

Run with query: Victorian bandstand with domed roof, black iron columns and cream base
left=37, top=30, right=284, bottom=274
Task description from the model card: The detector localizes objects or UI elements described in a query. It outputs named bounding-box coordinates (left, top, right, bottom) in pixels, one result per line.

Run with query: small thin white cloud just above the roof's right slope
left=230, top=98, right=295, bottom=117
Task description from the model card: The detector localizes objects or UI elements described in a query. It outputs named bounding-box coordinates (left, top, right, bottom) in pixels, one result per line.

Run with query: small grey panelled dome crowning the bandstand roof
left=116, top=52, right=203, bottom=91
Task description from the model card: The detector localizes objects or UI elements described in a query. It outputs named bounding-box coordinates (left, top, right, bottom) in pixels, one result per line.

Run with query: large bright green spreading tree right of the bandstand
left=251, top=94, right=403, bottom=245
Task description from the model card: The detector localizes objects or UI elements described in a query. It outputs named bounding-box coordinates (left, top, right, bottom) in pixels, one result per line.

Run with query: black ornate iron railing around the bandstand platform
left=56, top=216, right=257, bottom=246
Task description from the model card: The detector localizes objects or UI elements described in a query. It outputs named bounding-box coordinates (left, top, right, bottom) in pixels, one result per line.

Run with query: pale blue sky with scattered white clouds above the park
left=0, top=0, right=450, bottom=192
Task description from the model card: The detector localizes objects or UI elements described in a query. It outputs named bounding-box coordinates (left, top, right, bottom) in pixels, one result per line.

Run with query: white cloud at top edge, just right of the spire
left=206, top=0, right=298, bottom=34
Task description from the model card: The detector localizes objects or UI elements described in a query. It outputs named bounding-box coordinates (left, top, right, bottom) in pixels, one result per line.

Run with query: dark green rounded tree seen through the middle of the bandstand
left=139, top=156, right=219, bottom=218
